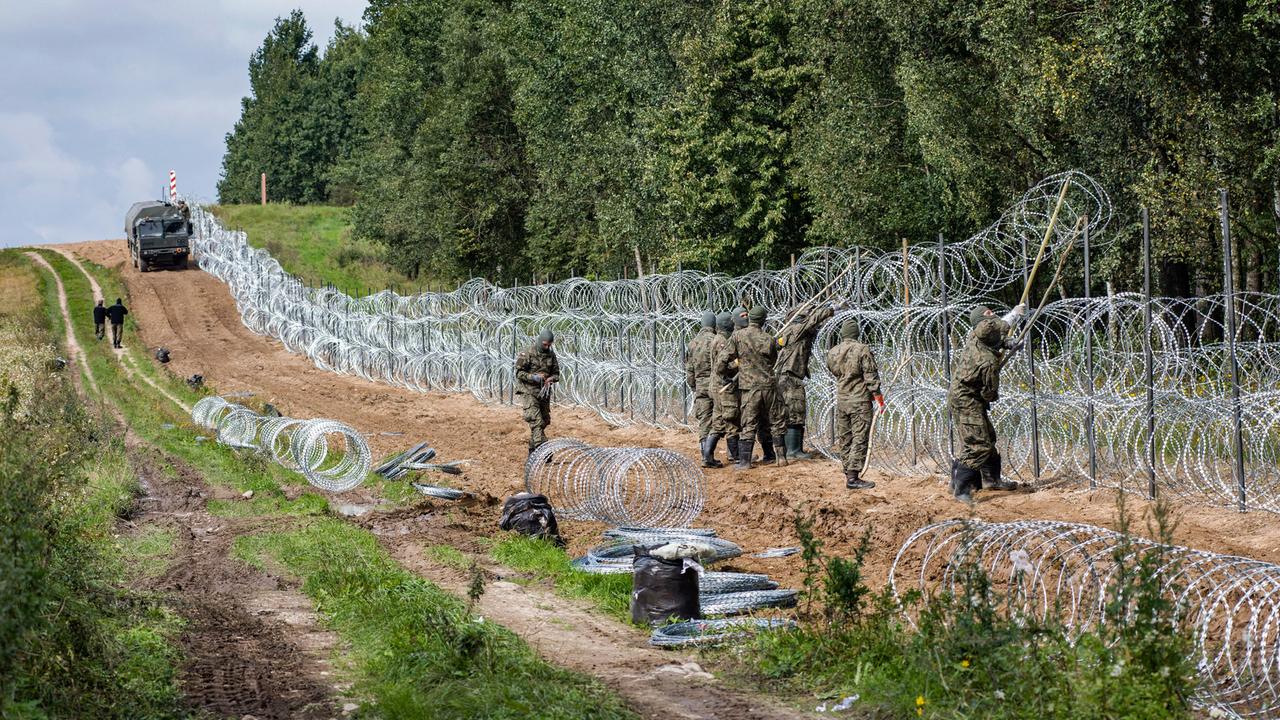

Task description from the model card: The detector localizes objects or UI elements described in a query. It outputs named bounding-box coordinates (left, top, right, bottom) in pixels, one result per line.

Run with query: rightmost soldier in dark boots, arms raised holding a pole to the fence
left=947, top=305, right=1024, bottom=502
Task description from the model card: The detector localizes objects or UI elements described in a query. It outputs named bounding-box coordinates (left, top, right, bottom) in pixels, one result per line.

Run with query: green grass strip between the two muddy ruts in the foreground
left=234, top=519, right=632, bottom=719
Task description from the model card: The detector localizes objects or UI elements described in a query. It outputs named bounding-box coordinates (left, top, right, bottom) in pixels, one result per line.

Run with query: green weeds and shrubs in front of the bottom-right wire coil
left=717, top=506, right=1196, bottom=720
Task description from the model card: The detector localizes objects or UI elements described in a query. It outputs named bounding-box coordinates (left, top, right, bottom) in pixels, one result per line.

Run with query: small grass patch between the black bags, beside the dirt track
left=492, top=534, right=631, bottom=621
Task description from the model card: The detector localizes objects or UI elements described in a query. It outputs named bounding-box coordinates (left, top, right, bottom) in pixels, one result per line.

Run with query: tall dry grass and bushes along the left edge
left=0, top=288, right=179, bottom=717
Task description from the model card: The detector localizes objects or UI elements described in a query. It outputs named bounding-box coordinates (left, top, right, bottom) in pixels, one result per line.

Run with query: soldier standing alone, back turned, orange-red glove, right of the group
left=827, top=320, right=884, bottom=489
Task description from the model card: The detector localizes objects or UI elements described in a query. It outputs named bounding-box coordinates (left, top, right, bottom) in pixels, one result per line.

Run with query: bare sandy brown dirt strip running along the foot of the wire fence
left=70, top=241, right=1280, bottom=585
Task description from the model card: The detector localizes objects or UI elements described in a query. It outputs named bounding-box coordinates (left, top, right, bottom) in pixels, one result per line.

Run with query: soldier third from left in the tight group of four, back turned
left=716, top=305, right=787, bottom=470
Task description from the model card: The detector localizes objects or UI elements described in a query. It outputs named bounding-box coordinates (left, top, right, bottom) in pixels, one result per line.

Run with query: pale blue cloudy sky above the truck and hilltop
left=0, top=0, right=365, bottom=247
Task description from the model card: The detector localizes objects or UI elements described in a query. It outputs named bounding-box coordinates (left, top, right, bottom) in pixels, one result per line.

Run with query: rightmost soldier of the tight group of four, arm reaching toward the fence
left=771, top=306, right=836, bottom=460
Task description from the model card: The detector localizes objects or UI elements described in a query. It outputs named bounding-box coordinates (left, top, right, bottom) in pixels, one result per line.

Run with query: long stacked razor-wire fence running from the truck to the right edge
left=192, top=172, right=1280, bottom=511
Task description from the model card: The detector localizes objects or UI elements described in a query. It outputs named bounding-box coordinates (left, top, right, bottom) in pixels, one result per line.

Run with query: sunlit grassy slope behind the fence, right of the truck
left=210, top=205, right=425, bottom=295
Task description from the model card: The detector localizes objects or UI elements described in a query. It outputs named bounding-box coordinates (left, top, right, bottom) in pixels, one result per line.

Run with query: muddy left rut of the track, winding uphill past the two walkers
left=37, top=243, right=351, bottom=720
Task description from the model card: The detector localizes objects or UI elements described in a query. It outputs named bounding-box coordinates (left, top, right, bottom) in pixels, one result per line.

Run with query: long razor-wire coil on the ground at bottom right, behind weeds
left=890, top=520, right=1280, bottom=717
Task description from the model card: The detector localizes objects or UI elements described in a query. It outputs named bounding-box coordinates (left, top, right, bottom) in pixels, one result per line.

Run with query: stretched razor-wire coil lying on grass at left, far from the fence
left=191, top=396, right=372, bottom=492
